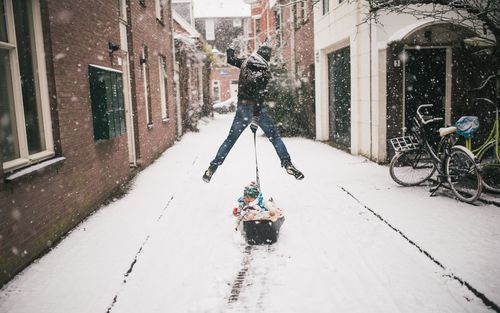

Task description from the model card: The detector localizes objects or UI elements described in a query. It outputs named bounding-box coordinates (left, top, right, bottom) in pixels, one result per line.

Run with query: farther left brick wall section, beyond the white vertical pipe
left=130, top=1, right=177, bottom=164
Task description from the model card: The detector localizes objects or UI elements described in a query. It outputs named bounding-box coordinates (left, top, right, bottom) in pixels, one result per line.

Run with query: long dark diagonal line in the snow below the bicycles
left=337, top=185, right=500, bottom=313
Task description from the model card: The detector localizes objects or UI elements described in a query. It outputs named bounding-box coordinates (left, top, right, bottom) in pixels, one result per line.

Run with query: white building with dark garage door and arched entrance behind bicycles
left=314, top=0, right=492, bottom=162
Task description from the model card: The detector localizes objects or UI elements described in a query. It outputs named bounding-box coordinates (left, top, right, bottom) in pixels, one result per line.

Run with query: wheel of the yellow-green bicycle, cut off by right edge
left=478, top=141, right=500, bottom=192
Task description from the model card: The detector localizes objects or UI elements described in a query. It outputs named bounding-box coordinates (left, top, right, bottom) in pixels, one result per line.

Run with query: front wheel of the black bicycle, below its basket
left=389, top=148, right=436, bottom=186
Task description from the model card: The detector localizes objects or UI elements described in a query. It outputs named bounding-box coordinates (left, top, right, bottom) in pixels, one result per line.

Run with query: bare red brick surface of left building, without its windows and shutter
left=0, top=0, right=177, bottom=285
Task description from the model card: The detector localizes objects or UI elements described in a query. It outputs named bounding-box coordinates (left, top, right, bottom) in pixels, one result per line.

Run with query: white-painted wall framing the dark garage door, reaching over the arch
left=314, top=0, right=450, bottom=161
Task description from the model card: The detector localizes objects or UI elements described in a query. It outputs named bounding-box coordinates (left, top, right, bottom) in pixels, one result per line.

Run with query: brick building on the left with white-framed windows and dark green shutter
left=0, top=0, right=177, bottom=285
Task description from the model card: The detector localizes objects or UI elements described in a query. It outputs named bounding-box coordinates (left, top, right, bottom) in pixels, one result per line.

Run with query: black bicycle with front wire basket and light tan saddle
left=389, top=104, right=482, bottom=203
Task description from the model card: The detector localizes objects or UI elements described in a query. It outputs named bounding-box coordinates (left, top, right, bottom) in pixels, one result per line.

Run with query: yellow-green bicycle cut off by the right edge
left=465, top=75, right=500, bottom=193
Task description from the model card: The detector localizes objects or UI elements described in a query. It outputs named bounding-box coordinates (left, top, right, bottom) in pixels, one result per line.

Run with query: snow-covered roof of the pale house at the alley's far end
left=194, top=0, right=250, bottom=18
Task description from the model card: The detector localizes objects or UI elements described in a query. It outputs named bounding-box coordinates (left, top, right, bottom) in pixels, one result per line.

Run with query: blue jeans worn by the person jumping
left=210, top=104, right=290, bottom=166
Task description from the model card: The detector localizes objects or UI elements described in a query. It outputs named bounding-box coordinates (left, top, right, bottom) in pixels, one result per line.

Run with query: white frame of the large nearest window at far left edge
left=0, top=0, right=55, bottom=171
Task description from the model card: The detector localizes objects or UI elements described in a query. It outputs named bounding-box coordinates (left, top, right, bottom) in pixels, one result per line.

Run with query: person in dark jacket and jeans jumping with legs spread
left=203, top=42, right=304, bottom=183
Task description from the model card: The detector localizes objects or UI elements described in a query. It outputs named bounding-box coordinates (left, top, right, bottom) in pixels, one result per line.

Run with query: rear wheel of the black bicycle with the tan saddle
left=445, top=146, right=483, bottom=203
